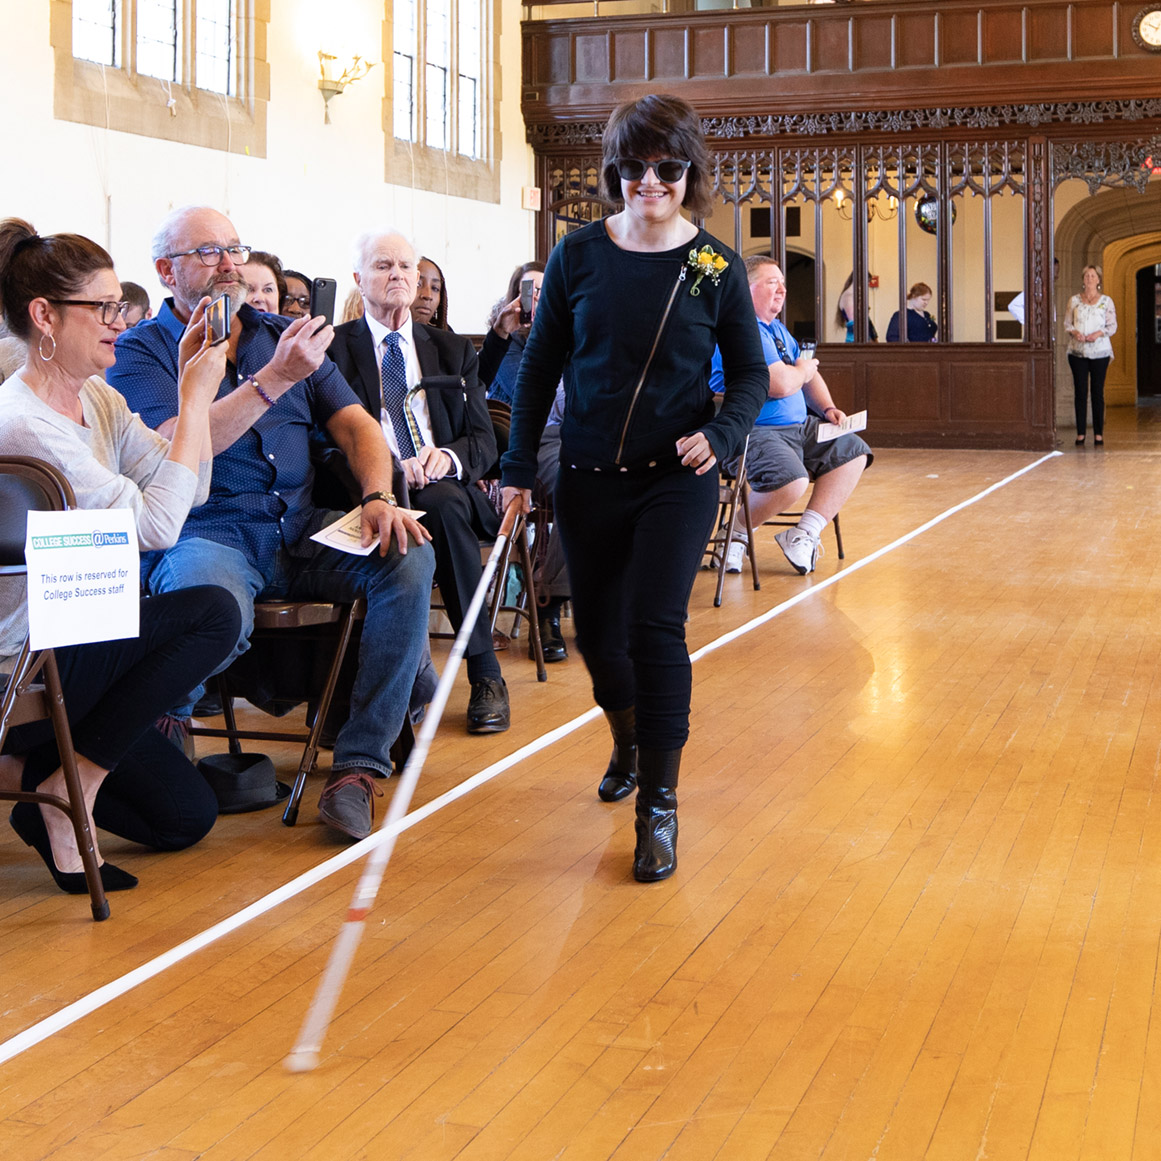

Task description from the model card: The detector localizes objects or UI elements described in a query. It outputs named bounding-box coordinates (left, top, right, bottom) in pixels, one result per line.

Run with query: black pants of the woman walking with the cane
left=555, top=462, right=717, bottom=750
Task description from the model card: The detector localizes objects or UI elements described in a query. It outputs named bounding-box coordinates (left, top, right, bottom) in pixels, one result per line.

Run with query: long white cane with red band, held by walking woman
left=283, top=497, right=520, bottom=1073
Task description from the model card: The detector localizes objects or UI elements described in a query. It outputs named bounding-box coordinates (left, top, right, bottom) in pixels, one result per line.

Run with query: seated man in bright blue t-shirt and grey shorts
left=709, top=255, right=874, bottom=576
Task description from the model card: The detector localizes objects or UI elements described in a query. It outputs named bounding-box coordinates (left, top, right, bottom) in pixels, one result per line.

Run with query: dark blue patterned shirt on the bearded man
left=106, top=298, right=360, bottom=579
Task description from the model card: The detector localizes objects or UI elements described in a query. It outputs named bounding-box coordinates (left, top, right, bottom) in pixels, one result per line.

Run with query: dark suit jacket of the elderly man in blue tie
left=327, top=318, right=498, bottom=484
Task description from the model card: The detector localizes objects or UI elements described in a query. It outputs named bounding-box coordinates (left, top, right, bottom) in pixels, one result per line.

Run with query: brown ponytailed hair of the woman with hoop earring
left=0, top=218, right=113, bottom=342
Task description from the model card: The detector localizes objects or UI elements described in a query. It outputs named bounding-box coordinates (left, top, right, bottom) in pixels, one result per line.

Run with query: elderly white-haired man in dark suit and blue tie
left=329, top=231, right=510, bottom=734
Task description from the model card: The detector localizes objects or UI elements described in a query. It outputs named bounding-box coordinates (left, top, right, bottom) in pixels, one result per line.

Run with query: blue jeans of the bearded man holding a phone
left=142, top=536, right=435, bottom=774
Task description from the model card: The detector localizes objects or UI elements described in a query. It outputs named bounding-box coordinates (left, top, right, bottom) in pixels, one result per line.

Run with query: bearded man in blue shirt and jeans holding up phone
left=109, top=207, right=434, bottom=838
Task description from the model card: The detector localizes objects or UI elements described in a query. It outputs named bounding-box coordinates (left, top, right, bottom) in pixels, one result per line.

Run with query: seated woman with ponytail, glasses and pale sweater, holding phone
left=0, top=218, right=239, bottom=894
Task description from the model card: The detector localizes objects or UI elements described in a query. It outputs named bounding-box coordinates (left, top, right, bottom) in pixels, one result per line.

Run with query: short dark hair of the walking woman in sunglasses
left=600, top=93, right=714, bottom=217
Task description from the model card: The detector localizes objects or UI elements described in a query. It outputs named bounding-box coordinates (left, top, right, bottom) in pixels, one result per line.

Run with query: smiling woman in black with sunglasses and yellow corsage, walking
left=502, top=95, right=770, bottom=882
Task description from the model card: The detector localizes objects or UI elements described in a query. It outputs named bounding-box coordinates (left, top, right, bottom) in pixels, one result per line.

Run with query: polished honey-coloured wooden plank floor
left=0, top=411, right=1161, bottom=1161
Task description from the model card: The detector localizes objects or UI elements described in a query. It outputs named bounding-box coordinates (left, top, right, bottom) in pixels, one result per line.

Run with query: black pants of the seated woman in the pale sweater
left=5, top=586, right=240, bottom=850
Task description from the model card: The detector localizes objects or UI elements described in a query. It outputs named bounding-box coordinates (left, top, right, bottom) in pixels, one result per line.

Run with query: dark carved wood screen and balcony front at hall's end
left=522, top=0, right=1161, bottom=448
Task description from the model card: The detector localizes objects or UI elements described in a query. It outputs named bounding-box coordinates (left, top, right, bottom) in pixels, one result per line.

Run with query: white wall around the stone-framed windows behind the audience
left=0, top=0, right=534, bottom=332
